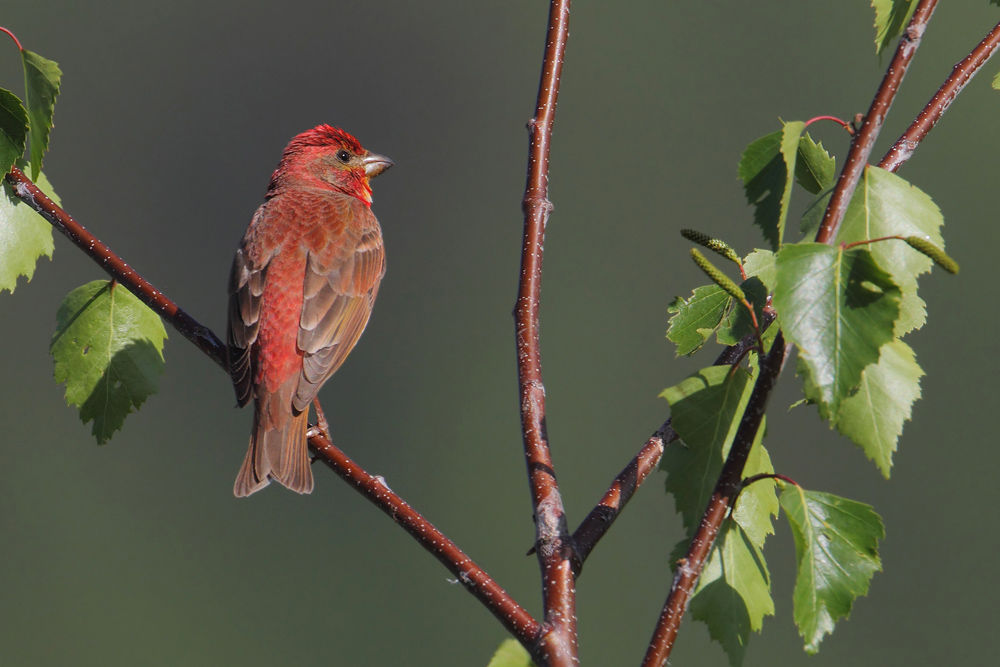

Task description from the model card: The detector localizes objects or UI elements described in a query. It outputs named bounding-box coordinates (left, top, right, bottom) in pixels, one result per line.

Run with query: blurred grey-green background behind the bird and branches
left=0, top=0, right=1000, bottom=667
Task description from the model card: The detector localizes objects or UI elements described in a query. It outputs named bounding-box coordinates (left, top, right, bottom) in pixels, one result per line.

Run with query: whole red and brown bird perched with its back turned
left=227, top=125, right=392, bottom=497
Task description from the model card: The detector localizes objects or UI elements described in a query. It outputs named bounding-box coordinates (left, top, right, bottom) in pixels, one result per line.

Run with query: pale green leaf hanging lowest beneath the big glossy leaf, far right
left=837, top=340, right=924, bottom=479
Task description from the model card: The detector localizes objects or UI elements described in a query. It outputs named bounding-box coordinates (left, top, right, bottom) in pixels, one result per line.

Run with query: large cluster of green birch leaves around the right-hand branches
left=661, top=117, right=957, bottom=665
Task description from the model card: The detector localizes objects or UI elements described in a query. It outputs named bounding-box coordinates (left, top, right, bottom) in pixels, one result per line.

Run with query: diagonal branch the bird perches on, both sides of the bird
left=6, top=167, right=542, bottom=653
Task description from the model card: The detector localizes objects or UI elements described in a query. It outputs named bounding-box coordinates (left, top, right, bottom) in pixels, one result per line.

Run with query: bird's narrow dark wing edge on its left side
left=226, top=206, right=267, bottom=407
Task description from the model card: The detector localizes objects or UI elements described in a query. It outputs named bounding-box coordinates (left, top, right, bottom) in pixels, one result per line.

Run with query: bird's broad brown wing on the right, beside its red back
left=292, top=206, right=385, bottom=410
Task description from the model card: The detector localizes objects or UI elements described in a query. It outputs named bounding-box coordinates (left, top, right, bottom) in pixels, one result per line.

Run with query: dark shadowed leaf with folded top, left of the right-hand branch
left=660, top=366, right=753, bottom=534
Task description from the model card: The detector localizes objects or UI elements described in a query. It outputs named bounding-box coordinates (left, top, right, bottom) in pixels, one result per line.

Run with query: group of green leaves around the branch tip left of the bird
left=0, top=31, right=167, bottom=444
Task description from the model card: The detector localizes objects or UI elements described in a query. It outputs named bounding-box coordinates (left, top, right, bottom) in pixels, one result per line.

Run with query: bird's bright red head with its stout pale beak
left=267, top=125, right=392, bottom=205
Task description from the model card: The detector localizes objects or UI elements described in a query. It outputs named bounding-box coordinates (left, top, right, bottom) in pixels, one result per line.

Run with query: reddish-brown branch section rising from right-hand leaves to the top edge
left=816, top=0, right=937, bottom=244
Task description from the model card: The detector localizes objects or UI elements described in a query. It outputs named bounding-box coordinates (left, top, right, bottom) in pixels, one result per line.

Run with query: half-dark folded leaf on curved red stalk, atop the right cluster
left=737, top=121, right=805, bottom=250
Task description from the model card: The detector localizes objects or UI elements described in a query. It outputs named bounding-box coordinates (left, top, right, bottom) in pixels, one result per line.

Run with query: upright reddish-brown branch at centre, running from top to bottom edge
left=514, top=0, right=579, bottom=667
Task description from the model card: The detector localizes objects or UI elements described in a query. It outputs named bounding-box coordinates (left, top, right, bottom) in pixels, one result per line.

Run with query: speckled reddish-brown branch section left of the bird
left=6, top=167, right=226, bottom=369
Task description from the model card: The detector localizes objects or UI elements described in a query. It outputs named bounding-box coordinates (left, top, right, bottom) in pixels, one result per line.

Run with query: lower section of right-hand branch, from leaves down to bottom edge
left=642, top=332, right=786, bottom=667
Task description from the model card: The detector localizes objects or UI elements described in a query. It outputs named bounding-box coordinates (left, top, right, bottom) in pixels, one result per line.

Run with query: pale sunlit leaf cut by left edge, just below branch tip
left=0, top=173, right=59, bottom=292
